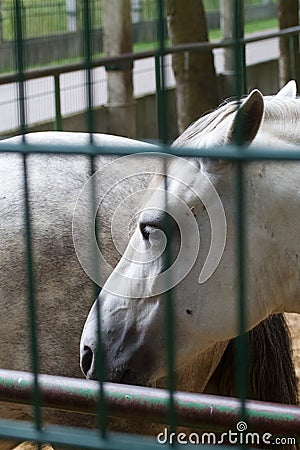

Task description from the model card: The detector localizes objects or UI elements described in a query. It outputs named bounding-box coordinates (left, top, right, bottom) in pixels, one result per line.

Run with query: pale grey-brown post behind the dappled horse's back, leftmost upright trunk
left=103, top=0, right=136, bottom=137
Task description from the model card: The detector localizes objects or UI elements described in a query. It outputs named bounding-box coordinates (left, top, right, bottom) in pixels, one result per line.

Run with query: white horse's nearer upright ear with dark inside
left=226, top=89, right=265, bottom=145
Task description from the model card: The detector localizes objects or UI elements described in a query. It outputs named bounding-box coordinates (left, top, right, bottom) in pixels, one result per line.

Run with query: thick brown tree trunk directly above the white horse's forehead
left=166, top=0, right=219, bottom=133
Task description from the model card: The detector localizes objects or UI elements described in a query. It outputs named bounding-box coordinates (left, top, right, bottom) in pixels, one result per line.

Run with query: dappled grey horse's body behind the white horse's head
left=0, top=132, right=232, bottom=449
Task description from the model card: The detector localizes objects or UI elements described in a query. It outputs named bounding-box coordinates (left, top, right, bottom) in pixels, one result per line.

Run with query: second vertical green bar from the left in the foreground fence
left=83, top=0, right=107, bottom=438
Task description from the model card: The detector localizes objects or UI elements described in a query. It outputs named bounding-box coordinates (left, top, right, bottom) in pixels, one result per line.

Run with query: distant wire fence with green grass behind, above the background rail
left=0, top=0, right=277, bottom=72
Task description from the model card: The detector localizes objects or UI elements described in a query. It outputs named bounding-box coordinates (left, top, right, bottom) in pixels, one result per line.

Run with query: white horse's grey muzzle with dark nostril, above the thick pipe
left=80, top=301, right=157, bottom=385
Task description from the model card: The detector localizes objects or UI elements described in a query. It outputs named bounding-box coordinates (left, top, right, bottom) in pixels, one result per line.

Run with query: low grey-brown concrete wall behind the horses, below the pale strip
left=15, top=60, right=279, bottom=141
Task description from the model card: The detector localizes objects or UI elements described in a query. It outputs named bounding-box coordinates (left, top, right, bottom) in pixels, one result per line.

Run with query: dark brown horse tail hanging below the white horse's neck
left=211, top=314, right=299, bottom=450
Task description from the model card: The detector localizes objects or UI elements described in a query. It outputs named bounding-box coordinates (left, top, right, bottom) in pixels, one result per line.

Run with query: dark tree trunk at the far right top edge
left=278, top=0, right=300, bottom=87
